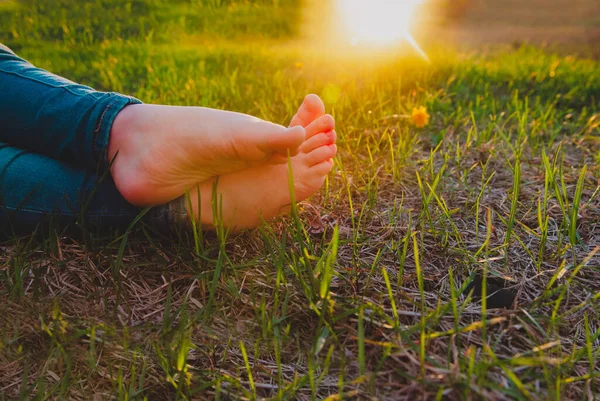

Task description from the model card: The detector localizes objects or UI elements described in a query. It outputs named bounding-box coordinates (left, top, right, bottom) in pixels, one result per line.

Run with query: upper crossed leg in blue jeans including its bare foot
left=0, top=49, right=305, bottom=206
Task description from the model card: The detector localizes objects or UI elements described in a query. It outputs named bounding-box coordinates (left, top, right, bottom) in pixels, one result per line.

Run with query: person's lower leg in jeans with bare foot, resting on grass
left=0, top=96, right=336, bottom=233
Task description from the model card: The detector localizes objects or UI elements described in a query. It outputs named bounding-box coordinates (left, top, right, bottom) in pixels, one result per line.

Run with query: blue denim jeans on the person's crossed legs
left=0, top=44, right=172, bottom=234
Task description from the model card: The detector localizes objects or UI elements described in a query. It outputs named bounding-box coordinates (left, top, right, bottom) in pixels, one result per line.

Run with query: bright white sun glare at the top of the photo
left=336, top=0, right=427, bottom=58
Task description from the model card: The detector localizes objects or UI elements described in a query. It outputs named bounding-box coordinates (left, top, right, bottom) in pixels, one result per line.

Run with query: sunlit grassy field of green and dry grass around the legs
left=0, top=0, right=600, bottom=401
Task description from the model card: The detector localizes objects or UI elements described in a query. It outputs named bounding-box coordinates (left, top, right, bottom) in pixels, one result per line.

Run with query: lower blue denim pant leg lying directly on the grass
left=0, top=143, right=174, bottom=235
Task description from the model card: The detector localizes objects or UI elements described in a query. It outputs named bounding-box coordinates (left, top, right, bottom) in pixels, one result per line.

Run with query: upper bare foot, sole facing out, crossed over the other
left=108, top=104, right=305, bottom=206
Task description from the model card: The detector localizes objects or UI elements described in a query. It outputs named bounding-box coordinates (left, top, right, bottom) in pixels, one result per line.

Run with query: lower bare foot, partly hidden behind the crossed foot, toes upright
left=190, top=95, right=337, bottom=230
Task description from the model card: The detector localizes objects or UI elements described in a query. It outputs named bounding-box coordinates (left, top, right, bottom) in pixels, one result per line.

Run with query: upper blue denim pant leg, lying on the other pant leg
left=0, top=46, right=141, bottom=170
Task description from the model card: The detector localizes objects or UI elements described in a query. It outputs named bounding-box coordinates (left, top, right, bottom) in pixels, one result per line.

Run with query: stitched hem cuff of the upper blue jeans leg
left=92, top=92, right=142, bottom=167
